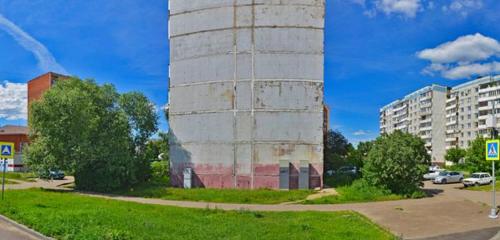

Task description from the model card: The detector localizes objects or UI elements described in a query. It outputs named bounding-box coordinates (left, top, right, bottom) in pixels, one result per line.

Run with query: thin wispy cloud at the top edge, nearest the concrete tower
left=375, top=0, right=422, bottom=18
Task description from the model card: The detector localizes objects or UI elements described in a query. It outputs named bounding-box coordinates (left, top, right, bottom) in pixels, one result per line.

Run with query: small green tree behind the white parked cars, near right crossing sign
left=465, top=136, right=491, bottom=172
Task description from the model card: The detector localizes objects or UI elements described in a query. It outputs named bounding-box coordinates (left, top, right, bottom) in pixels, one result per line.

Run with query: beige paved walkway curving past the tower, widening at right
left=4, top=178, right=500, bottom=240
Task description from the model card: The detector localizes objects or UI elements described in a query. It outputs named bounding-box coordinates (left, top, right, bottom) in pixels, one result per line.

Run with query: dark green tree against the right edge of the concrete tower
left=324, top=130, right=354, bottom=171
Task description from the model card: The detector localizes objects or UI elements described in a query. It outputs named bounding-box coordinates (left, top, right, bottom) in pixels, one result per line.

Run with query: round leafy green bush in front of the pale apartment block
left=363, top=131, right=430, bottom=195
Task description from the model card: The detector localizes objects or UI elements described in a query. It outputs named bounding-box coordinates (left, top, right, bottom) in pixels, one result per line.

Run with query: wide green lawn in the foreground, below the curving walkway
left=0, top=189, right=396, bottom=240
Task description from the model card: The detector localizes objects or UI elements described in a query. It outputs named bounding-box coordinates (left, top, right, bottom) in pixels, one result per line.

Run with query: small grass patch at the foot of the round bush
left=303, top=180, right=405, bottom=204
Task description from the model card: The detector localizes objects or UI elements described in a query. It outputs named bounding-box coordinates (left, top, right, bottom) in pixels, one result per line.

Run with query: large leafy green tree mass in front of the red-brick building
left=25, top=78, right=156, bottom=191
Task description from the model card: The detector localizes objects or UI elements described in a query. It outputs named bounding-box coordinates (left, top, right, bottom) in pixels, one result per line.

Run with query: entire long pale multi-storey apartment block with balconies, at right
left=380, top=75, right=500, bottom=164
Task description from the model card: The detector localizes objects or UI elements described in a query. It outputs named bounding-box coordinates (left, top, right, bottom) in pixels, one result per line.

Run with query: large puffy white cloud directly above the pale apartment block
left=417, top=33, right=500, bottom=79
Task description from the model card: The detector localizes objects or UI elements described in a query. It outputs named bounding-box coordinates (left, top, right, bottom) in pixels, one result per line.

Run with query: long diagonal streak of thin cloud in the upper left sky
left=0, top=14, right=68, bottom=74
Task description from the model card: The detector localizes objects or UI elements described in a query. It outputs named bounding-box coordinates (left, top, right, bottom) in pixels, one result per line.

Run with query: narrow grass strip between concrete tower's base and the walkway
left=116, top=184, right=313, bottom=204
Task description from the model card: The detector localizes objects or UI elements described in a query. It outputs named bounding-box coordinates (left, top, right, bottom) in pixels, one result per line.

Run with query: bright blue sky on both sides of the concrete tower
left=0, top=0, right=500, bottom=143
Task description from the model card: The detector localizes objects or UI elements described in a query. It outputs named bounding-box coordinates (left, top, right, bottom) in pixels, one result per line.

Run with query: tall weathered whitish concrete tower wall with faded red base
left=169, top=0, right=325, bottom=188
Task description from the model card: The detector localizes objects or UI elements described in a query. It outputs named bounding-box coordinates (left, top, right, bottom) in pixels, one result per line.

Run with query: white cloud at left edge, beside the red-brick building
left=0, top=81, right=28, bottom=120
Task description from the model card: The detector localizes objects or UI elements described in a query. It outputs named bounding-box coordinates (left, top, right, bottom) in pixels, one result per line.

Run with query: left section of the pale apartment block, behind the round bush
left=380, top=85, right=448, bottom=163
